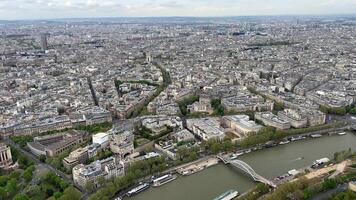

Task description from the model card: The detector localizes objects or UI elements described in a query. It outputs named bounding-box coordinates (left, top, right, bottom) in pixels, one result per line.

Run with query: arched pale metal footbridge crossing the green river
left=217, top=156, right=277, bottom=188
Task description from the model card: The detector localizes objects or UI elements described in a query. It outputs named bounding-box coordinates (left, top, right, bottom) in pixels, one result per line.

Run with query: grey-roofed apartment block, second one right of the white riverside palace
left=277, top=109, right=308, bottom=128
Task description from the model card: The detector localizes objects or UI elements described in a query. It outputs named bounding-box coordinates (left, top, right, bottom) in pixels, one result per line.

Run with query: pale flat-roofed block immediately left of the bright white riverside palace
left=187, top=118, right=225, bottom=141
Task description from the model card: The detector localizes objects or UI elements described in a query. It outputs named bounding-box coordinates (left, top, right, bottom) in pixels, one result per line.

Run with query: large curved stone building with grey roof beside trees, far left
left=27, top=130, right=88, bottom=157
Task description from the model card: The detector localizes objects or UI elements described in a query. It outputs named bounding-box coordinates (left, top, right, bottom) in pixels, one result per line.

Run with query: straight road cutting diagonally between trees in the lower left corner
left=4, top=139, right=89, bottom=199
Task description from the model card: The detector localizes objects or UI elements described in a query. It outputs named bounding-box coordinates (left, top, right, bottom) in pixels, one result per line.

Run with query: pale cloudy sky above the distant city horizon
left=0, top=0, right=356, bottom=20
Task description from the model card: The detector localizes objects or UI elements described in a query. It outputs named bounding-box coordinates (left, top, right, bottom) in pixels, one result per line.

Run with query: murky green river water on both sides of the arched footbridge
left=128, top=133, right=356, bottom=200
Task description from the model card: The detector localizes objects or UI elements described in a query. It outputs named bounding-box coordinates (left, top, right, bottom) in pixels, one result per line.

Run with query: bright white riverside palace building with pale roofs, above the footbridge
left=222, top=115, right=263, bottom=135
